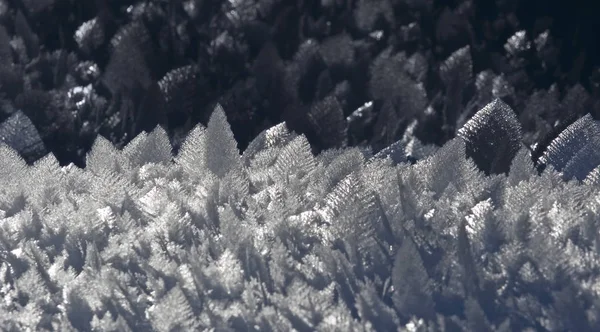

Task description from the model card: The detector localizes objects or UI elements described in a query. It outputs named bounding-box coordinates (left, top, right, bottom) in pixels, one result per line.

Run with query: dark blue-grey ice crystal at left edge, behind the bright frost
left=0, top=111, right=47, bottom=162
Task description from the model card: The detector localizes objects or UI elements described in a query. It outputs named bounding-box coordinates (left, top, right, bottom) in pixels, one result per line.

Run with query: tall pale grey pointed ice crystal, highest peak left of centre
left=204, top=104, right=242, bottom=178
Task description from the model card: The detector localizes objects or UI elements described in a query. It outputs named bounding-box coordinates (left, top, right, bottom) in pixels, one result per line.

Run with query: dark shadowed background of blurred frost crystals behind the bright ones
left=0, top=0, right=600, bottom=171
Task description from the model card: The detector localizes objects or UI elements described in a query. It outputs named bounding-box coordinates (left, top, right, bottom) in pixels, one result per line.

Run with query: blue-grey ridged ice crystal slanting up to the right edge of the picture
left=539, top=113, right=600, bottom=171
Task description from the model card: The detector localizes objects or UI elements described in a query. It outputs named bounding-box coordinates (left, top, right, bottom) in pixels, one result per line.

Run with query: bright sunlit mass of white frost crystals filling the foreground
left=0, top=100, right=600, bottom=331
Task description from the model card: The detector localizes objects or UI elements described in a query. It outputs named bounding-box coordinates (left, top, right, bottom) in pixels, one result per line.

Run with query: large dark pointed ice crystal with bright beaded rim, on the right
left=458, top=99, right=521, bottom=174
